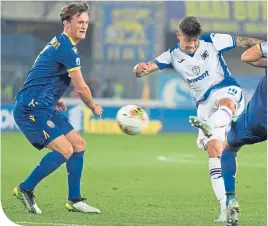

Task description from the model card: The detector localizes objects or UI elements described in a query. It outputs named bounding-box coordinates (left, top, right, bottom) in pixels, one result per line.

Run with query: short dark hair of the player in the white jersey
left=178, top=16, right=202, bottom=36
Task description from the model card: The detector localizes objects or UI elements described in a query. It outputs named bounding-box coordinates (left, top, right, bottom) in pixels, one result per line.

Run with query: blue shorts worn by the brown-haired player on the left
left=13, top=103, right=74, bottom=150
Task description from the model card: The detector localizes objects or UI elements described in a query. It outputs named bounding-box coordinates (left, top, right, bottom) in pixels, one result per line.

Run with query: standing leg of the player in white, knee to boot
left=206, top=139, right=226, bottom=222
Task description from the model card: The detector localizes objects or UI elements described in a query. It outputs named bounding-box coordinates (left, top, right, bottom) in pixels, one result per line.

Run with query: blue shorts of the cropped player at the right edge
left=227, top=113, right=267, bottom=148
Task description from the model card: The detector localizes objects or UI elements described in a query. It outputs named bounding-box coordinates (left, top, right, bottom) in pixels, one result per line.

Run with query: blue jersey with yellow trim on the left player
left=15, top=33, right=80, bottom=115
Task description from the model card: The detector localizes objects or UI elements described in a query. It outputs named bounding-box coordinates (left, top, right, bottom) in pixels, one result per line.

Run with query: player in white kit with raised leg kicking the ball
left=133, top=16, right=260, bottom=221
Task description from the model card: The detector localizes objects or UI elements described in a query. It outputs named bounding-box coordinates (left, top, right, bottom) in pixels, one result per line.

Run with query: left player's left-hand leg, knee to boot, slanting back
left=13, top=135, right=73, bottom=214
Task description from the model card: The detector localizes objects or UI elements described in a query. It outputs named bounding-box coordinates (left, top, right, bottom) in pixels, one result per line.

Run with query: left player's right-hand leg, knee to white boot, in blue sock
left=65, top=130, right=100, bottom=213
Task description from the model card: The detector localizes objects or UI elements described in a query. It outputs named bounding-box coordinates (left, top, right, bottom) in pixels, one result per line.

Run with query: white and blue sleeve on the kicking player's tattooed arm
left=210, top=33, right=236, bottom=52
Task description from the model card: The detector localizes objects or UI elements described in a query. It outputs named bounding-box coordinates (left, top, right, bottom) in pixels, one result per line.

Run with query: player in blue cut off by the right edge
left=221, top=42, right=267, bottom=226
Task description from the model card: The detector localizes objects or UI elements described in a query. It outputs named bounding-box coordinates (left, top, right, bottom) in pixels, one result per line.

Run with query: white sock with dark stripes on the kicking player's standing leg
left=208, top=158, right=226, bottom=211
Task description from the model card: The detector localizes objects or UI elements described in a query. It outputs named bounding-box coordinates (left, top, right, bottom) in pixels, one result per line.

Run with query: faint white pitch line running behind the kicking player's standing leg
left=156, top=155, right=266, bottom=169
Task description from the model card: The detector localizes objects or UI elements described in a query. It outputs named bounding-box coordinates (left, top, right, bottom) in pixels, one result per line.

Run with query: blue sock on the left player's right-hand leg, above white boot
left=66, top=151, right=85, bottom=200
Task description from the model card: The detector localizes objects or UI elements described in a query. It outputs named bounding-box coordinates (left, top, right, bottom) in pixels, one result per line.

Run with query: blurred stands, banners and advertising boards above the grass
left=1, top=1, right=267, bottom=133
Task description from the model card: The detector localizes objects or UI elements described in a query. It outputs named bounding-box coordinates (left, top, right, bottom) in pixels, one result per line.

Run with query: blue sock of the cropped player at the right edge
left=221, top=147, right=237, bottom=205
